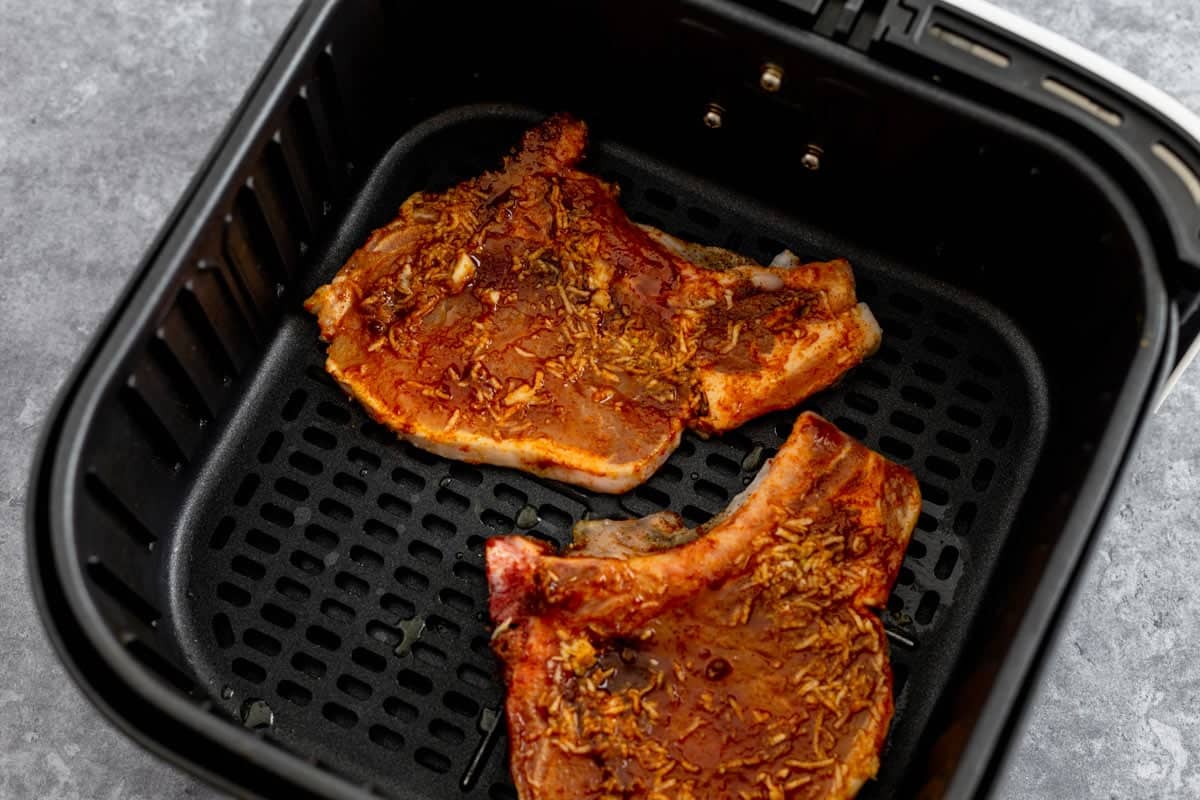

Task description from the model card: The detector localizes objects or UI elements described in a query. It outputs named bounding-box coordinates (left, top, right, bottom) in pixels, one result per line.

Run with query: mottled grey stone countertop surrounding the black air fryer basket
left=0, top=0, right=1200, bottom=800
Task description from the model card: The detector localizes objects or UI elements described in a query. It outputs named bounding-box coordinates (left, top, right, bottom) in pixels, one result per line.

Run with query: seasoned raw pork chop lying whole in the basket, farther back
left=306, top=115, right=880, bottom=492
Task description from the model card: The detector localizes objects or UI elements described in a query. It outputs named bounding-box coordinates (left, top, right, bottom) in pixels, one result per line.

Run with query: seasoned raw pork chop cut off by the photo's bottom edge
left=486, top=414, right=920, bottom=800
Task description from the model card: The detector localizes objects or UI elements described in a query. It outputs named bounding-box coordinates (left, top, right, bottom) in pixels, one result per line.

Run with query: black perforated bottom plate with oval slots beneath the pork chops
left=173, top=110, right=1040, bottom=798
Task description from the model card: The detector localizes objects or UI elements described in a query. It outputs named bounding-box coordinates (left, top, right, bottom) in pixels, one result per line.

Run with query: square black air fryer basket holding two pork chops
left=30, top=0, right=1192, bottom=798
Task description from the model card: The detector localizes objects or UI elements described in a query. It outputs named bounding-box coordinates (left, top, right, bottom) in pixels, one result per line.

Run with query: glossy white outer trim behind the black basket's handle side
left=943, top=0, right=1200, bottom=413
